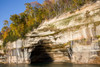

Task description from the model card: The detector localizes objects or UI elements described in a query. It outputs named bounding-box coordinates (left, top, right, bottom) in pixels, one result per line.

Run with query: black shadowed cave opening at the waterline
left=30, top=39, right=53, bottom=64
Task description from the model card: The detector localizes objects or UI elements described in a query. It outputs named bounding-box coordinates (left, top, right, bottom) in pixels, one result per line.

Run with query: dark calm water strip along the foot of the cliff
left=0, top=63, right=100, bottom=67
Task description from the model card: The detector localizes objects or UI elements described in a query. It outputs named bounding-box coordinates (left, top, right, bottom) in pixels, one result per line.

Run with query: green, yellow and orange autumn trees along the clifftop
left=0, top=0, right=96, bottom=45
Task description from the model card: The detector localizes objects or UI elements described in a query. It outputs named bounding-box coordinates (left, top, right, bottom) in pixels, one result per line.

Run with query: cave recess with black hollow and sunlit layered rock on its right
left=30, top=40, right=69, bottom=63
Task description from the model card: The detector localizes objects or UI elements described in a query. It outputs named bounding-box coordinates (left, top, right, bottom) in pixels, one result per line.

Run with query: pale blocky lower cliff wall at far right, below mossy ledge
left=72, top=39, right=100, bottom=64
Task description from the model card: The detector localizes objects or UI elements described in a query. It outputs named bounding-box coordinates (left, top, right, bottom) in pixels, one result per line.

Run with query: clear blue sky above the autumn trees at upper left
left=0, top=0, right=43, bottom=31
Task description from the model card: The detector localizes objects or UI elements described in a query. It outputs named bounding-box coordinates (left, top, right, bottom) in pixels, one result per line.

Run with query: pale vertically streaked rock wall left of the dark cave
left=6, top=39, right=32, bottom=63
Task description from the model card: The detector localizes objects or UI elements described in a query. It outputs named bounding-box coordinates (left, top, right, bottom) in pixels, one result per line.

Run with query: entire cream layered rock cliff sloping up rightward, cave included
left=7, top=1, right=100, bottom=64
